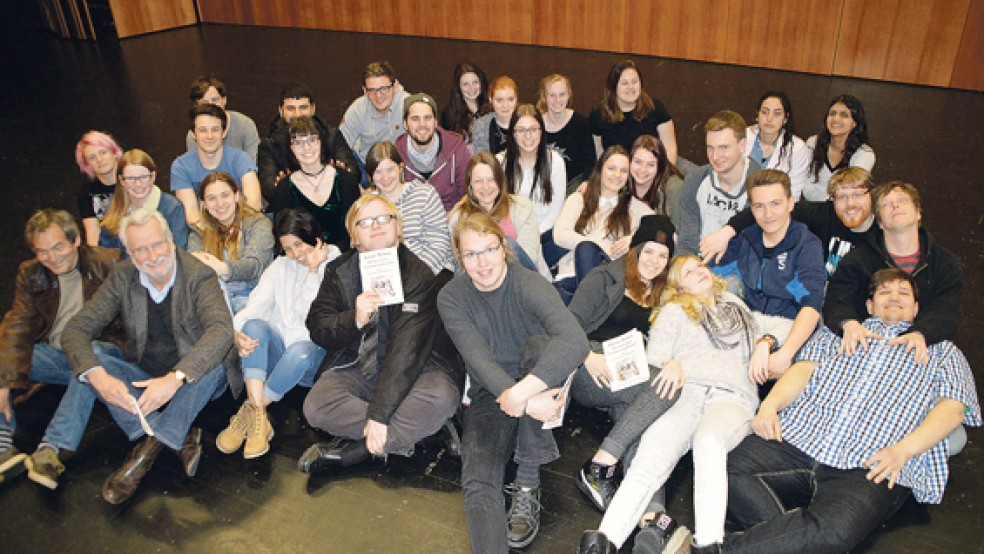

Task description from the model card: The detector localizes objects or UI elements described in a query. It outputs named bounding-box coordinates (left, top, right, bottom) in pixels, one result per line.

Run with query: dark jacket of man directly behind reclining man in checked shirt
left=823, top=227, right=963, bottom=344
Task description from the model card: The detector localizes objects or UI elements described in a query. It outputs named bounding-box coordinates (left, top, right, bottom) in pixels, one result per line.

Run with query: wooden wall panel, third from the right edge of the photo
left=724, top=0, right=842, bottom=74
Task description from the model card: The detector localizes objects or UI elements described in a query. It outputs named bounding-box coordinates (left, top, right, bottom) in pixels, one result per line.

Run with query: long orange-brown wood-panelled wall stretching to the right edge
left=194, top=0, right=984, bottom=90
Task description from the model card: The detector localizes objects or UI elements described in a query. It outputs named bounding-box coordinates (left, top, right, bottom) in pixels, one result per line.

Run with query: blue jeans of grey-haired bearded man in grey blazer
left=85, top=355, right=227, bottom=451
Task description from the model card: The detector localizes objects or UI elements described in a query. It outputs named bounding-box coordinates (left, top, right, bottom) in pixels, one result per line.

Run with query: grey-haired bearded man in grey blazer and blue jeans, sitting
left=62, top=209, right=243, bottom=504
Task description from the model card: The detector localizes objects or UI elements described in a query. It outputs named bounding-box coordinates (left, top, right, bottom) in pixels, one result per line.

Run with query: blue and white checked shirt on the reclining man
left=779, top=317, right=981, bottom=504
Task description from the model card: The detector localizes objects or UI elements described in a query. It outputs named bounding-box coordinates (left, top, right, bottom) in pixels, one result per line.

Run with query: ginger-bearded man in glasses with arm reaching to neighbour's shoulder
left=700, top=167, right=878, bottom=277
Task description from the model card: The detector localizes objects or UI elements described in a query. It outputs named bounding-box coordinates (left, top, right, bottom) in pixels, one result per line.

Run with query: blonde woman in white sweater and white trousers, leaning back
left=579, top=256, right=792, bottom=553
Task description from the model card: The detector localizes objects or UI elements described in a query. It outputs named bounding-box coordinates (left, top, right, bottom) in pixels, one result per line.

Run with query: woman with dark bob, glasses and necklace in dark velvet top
left=270, top=115, right=361, bottom=252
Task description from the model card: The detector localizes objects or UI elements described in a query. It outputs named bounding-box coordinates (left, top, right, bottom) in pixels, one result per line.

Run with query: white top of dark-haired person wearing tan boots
left=232, top=254, right=338, bottom=348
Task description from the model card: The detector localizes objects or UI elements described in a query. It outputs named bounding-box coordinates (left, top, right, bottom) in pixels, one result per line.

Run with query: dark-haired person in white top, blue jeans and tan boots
left=215, top=208, right=341, bottom=459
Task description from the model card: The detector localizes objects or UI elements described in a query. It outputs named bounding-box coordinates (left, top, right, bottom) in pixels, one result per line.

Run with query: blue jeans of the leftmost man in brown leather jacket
left=0, top=341, right=123, bottom=450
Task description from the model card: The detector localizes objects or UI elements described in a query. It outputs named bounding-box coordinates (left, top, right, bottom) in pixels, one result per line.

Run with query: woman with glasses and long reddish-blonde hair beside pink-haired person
left=99, top=148, right=188, bottom=260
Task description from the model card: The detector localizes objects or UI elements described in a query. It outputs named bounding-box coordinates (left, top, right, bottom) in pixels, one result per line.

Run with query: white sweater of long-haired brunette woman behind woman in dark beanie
left=554, top=192, right=656, bottom=279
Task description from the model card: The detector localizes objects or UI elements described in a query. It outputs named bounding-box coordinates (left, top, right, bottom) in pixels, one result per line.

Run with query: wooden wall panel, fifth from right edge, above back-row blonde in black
left=533, top=0, right=629, bottom=52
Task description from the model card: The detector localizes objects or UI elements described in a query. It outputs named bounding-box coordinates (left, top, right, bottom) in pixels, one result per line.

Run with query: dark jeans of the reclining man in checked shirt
left=724, top=435, right=910, bottom=553
